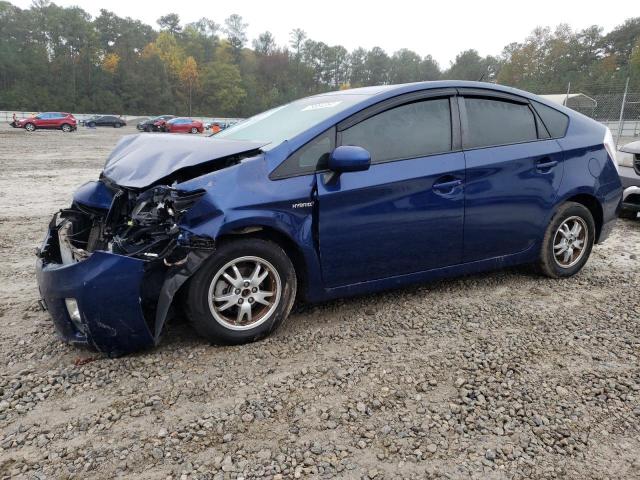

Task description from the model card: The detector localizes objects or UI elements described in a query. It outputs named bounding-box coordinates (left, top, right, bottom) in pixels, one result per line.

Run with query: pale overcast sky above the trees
left=11, top=0, right=640, bottom=68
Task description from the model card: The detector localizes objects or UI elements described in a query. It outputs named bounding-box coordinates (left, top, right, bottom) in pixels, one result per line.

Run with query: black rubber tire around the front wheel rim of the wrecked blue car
left=184, top=238, right=297, bottom=345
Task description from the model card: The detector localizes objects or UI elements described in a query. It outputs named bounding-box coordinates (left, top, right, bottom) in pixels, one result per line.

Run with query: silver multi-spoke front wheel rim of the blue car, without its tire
left=208, top=256, right=282, bottom=330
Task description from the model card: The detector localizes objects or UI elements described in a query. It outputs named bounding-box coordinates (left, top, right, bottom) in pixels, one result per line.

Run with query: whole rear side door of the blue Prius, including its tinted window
left=459, top=89, right=563, bottom=262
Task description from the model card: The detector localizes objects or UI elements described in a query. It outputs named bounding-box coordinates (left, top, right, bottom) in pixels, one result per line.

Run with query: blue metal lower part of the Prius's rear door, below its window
left=463, top=140, right=564, bottom=262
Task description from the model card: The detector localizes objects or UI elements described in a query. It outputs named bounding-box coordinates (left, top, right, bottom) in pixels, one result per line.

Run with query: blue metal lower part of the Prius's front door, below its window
left=316, top=152, right=465, bottom=288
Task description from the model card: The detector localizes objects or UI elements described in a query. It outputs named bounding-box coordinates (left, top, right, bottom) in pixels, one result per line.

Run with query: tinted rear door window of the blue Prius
left=463, top=97, right=538, bottom=149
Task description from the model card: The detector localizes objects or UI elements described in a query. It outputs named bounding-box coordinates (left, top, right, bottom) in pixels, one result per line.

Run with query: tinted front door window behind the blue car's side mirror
left=341, top=98, right=452, bottom=163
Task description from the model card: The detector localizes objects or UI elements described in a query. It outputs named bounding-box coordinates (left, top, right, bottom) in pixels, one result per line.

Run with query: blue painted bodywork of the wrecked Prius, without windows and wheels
left=33, top=81, right=622, bottom=353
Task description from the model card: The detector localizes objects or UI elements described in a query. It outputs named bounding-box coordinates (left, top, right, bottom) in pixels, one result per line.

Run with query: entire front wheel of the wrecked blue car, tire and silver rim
left=184, top=238, right=297, bottom=344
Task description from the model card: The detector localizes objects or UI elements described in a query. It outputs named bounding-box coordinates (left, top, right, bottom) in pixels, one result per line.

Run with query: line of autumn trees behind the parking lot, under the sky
left=0, top=0, right=640, bottom=117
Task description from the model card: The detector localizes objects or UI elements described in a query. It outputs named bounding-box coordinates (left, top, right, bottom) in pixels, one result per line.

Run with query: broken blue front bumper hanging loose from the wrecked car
left=36, top=215, right=212, bottom=356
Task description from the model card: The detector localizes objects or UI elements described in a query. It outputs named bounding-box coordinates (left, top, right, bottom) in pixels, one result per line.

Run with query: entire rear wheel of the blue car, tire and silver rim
left=538, top=202, right=596, bottom=278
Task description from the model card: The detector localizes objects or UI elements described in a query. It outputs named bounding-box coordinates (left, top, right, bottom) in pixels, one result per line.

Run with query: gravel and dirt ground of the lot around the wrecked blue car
left=0, top=126, right=640, bottom=479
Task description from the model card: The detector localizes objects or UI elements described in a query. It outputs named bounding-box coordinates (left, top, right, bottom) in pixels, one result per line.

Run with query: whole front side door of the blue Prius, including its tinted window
left=313, top=92, right=465, bottom=287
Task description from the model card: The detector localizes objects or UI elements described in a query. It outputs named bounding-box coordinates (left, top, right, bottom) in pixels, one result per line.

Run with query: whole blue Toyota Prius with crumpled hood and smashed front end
left=37, top=81, right=622, bottom=355
